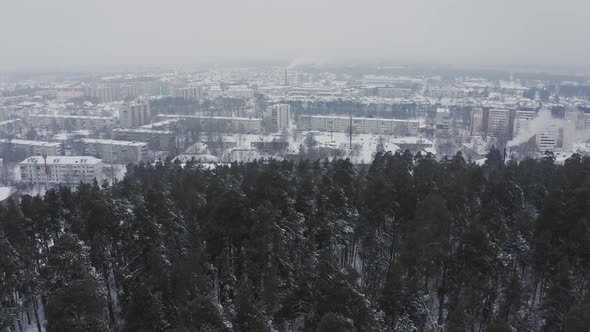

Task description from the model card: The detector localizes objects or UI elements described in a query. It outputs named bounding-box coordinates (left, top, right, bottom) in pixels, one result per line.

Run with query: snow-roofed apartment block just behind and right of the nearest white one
left=75, top=138, right=148, bottom=164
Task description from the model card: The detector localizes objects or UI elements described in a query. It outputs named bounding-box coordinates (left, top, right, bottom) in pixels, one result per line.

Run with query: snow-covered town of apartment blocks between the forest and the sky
left=0, top=66, right=590, bottom=195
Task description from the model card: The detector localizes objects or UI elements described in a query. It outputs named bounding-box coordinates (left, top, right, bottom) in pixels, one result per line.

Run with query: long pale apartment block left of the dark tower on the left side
left=27, top=114, right=116, bottom=131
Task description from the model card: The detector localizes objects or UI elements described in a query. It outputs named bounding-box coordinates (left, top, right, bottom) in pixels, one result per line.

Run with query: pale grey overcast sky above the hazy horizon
left=0, top=0, right=590, bottom=68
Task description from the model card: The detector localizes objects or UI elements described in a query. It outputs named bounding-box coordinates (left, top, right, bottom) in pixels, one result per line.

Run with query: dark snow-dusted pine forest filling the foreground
left=0, top=149, right=590, bottom=332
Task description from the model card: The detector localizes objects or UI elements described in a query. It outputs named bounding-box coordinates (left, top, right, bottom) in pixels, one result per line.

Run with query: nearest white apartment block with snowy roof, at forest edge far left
left=19, top=156, right=103, bottom=186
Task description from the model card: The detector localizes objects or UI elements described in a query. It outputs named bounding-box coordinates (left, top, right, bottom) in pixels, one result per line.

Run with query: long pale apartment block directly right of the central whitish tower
left=297, top=115, right=420, bottom=136
